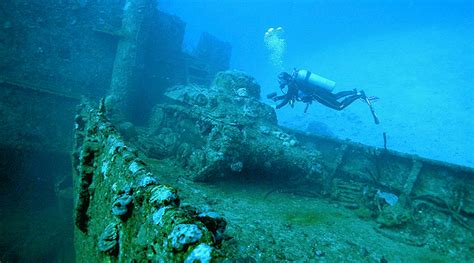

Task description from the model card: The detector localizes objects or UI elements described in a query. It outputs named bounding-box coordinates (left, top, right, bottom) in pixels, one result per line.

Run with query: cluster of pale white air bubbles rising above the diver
left=263, top=27, right=286, bottom=69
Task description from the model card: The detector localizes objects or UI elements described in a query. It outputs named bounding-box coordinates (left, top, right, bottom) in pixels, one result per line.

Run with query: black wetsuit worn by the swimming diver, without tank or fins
left=273, top=80, right=364, bottom=110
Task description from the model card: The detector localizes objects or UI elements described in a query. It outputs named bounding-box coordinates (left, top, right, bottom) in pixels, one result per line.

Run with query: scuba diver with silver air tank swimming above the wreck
left=267, top=69, right=379, bottom=124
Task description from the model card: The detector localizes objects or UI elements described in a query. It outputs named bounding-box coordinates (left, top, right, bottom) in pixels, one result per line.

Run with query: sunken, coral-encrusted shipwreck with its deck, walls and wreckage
left=0, top=0, right=474, bottom=262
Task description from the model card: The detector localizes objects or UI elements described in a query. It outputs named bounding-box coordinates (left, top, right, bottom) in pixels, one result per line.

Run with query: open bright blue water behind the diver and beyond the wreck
left=159, top=0, right=474, bottom=167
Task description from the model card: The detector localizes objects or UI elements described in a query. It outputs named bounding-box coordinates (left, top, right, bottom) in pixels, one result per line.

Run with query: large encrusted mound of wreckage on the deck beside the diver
left=143, top=71, right=321, bottom=184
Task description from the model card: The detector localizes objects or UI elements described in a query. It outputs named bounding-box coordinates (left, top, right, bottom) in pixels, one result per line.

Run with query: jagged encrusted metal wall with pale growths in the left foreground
left=73, top=101, right=225, bottom=262
